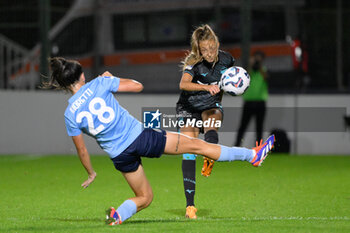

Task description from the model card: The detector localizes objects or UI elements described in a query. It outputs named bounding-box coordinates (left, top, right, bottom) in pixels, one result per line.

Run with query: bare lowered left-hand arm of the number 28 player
left=72, top=134, right=96, bottom=188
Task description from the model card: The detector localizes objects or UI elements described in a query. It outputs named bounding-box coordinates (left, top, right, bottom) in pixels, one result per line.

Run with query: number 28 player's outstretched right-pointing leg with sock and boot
left=164, top=132, right=275, bottom=167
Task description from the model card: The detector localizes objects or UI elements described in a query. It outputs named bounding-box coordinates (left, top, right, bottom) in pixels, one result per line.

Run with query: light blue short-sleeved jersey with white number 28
left=64, top=77, right=143, bottom=158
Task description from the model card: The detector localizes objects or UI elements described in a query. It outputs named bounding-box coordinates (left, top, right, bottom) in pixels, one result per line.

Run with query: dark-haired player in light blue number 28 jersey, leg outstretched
left=48, top=58, right=275, bottom=225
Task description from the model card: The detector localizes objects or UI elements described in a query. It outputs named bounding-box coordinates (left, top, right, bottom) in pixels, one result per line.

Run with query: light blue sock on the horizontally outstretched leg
left=217, top=145, right=255, bottom=162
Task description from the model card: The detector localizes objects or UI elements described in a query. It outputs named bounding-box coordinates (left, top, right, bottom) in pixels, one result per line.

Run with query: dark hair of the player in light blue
left=45, top=57, right=83, bottom=90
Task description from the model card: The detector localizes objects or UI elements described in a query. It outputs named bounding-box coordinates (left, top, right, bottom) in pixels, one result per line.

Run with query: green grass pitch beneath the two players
left=0, top=154, right=350, bottom=233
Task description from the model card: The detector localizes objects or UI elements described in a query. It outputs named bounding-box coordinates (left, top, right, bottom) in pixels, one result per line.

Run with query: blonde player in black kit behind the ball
left=176, top=25, right=235, bottom=218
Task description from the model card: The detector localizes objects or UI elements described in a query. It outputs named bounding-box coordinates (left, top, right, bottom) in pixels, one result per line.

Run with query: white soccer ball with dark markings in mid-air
left=220, top=66, right=250, bottom=96
